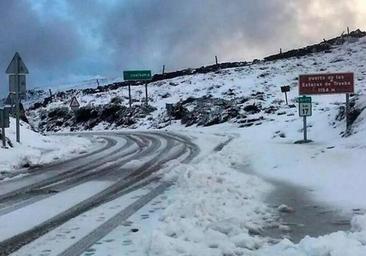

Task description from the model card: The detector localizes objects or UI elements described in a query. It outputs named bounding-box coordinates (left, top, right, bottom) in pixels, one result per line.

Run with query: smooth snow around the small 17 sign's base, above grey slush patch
left=234, top=113, right=366, bottom=209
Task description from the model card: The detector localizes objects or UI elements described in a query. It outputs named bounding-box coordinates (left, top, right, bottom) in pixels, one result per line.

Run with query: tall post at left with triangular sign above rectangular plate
left=6, top=53, right=29, bottom=142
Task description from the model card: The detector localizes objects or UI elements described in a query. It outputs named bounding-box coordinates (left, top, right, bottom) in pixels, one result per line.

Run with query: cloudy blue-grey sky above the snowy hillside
left=0, top=0, right=366, bottom=94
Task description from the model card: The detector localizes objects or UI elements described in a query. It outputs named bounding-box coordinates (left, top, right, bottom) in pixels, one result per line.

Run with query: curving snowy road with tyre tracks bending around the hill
left=0, top=132, right=199, bottom=255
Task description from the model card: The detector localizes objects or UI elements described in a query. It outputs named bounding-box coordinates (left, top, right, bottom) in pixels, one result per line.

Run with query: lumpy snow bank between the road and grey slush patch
left=146, top=141, right=273, bottom=256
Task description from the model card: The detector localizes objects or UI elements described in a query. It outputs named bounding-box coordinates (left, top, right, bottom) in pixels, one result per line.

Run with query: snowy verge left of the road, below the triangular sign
left=0, top=118, right=93, bottom=180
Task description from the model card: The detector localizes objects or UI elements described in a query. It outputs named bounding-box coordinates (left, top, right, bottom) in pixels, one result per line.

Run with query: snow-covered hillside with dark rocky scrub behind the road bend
left=28, top=31, right=366, bottom=136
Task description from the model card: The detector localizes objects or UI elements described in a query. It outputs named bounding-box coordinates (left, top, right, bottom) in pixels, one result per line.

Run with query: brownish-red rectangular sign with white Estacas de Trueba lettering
left=299, top=73, right=354, bottom=95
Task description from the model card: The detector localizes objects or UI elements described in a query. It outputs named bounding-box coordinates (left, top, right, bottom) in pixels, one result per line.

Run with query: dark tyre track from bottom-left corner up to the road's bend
left=0, top=132, right=199, bottom=255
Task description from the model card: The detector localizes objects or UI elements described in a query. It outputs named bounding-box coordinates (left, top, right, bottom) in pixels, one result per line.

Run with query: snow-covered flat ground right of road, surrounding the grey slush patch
left=136, top=127, right=366, bottom=256
